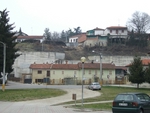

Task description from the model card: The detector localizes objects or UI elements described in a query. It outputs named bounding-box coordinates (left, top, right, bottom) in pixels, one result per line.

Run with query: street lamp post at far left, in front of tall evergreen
left=0, top=41, right=6, bottom=91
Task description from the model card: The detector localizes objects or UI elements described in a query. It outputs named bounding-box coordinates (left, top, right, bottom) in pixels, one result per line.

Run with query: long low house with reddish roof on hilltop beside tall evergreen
left=15, top=36, right=45, bottom=43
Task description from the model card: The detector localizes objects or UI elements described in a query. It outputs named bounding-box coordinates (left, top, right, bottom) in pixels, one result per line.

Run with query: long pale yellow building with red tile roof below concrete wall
left=30, top=62, right=124, bottom=84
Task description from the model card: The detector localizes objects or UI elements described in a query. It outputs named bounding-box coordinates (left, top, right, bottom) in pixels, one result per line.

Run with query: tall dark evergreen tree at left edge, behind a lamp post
left=0, top=9, right=18, bottom=73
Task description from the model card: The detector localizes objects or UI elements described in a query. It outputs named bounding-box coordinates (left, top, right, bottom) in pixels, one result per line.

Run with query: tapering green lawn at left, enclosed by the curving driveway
left=0, top=89, right=67, bottom=101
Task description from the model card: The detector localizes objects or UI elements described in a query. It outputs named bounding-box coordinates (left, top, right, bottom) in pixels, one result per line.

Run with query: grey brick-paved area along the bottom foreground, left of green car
left=0, top=102, right=111, bottom=113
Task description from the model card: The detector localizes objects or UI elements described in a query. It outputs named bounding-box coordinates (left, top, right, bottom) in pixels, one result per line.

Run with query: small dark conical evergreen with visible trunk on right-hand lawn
left=129, top=56, right=145, bottom=88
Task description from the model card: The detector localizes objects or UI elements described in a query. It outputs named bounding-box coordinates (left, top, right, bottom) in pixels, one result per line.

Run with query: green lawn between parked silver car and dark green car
left=65, top=86, right=150, bottom=110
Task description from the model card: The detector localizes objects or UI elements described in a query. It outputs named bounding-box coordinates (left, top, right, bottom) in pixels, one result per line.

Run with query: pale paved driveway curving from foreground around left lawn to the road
left=0, top=82, right=111, bottom=113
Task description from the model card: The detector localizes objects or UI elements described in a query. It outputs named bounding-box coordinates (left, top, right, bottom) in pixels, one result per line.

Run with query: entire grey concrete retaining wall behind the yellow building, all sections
left=13, top=52, right=150, bottom=77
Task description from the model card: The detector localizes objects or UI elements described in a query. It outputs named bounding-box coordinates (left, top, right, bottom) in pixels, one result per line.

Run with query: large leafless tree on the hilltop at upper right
left=127, top=11, right=150, bottom=34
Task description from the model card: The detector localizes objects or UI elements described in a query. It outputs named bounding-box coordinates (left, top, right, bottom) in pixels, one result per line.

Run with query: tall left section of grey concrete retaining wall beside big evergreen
left=13, top=52, right=65, bottom=77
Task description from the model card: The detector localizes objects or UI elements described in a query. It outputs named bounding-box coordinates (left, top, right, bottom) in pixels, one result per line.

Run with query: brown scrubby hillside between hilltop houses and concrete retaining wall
left=16, top=43, right=150, bottom=60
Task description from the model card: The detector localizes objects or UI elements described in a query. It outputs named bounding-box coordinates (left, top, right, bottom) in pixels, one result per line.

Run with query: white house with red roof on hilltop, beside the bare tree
left=104, top=26, right=128, bottom=43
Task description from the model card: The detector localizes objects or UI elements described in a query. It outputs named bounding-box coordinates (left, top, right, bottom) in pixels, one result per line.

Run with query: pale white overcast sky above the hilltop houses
left=0, top=0, right=150, bottom=35
